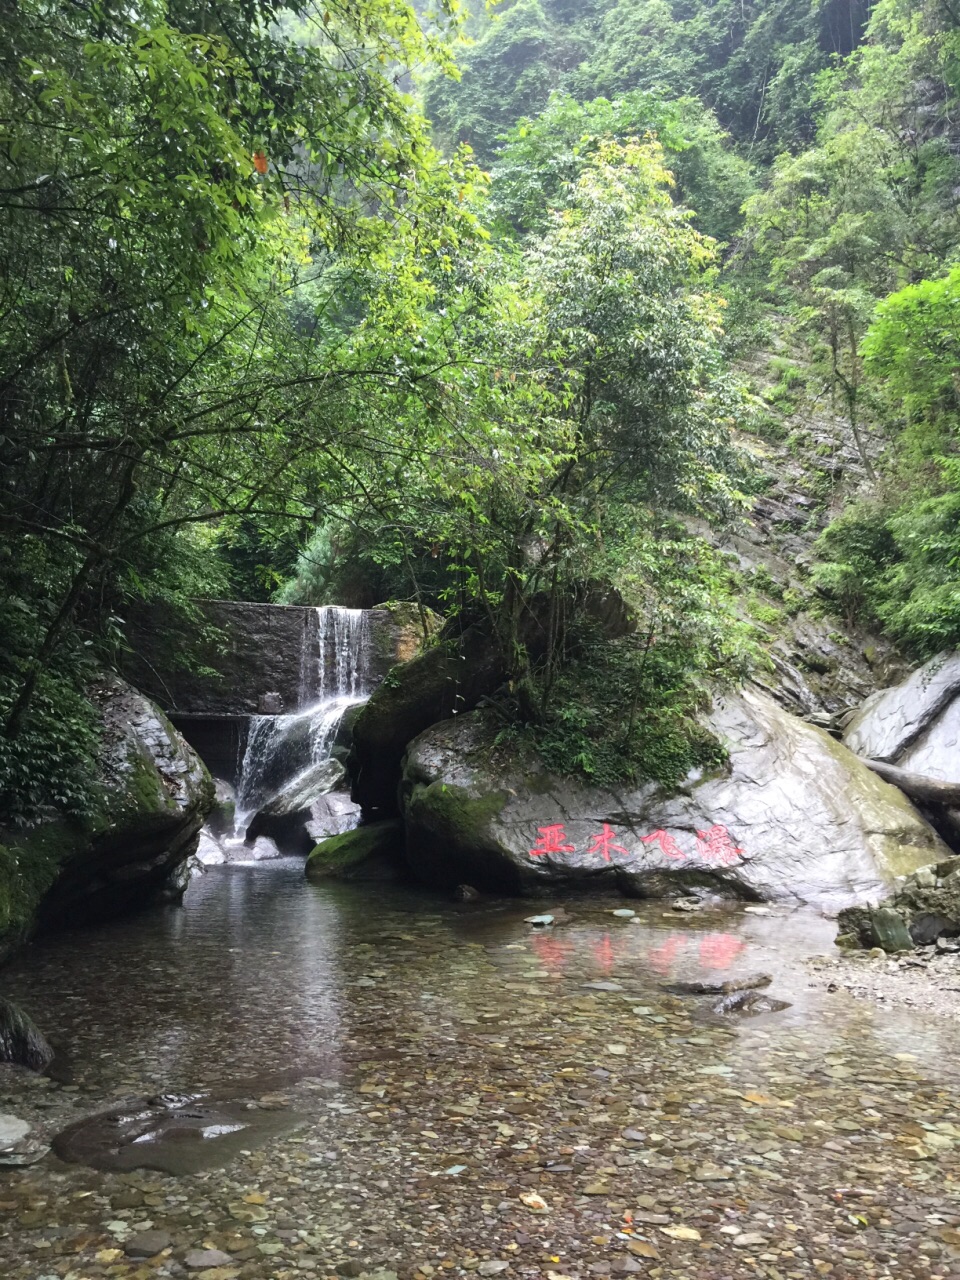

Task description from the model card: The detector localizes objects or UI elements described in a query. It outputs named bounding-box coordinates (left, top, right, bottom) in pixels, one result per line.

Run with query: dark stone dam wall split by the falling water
left=124, top=600, right=416, bottom=717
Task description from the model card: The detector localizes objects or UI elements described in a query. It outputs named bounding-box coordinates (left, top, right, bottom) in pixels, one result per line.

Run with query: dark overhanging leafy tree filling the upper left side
left=0, top=0, right=472, bottom=800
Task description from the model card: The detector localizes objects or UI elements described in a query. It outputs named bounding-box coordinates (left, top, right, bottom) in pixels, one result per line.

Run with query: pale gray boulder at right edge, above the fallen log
left=844, top=653, right=960, bottom=782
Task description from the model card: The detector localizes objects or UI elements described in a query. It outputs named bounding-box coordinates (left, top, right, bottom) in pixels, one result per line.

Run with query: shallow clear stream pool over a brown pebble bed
left=0, top=860, right=960, bottom=1280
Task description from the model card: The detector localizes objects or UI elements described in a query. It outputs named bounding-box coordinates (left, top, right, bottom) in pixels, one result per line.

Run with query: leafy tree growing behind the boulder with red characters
left=472, top=141, right=742, bottom=772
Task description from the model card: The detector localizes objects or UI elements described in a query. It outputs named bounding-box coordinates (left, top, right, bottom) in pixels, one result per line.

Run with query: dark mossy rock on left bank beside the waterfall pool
left=0, top=676, right=214, bottom=954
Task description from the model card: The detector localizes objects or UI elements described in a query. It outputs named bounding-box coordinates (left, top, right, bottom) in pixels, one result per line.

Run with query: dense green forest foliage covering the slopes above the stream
left=0, top=0, right=960, bottom=820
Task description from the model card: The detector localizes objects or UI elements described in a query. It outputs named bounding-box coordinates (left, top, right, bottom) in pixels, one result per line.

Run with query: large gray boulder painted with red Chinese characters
left=403, top=690, right=947, bottom=906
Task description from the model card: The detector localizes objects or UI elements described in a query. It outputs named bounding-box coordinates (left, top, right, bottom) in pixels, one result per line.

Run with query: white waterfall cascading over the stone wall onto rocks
left=229, top=604, right=370, bottom=838
